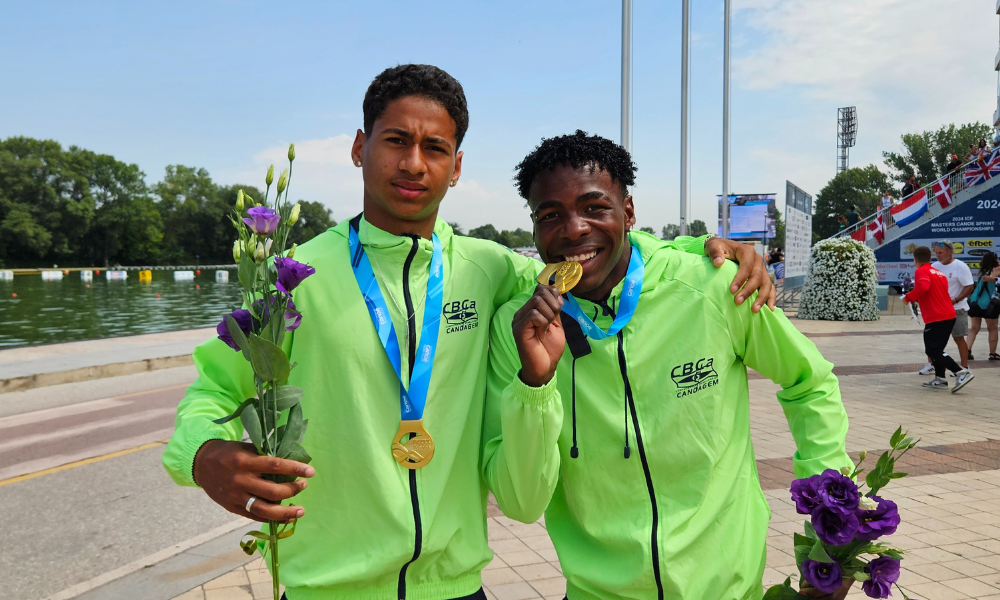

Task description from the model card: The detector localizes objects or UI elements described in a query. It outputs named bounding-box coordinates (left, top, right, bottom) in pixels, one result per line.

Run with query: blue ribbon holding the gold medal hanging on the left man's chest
left=348, top=221, right=444, bottom=421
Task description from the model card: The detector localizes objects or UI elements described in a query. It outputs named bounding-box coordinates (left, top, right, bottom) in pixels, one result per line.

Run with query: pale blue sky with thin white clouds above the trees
left=0, top=0, right=1000, bottom=232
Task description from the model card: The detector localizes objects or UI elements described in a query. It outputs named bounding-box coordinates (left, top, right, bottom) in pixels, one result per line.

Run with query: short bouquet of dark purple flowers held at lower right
left=764, top=427, right=919, bottom=600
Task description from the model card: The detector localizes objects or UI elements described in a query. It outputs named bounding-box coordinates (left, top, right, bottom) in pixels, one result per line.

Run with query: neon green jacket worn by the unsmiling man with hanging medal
left=163, top=219, right=704, bottom=600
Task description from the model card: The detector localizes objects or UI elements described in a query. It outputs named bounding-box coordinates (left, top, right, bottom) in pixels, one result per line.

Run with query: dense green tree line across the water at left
left=0, top=137, right=336, bottom=267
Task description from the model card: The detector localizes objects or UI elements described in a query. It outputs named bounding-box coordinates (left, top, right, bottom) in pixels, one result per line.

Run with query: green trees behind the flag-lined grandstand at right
left=813, top=123, right=993, bottom=242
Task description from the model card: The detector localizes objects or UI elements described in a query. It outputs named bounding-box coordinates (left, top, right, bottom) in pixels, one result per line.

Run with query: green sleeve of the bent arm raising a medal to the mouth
left=482, top=305, right=563, bottom=523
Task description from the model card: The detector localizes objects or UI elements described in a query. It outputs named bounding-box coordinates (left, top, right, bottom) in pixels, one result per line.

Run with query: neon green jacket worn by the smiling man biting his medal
left=483, top=233, right=850, bottom=600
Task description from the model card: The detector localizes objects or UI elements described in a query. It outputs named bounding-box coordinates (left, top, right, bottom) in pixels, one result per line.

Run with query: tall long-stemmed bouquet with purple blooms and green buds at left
left=215, top=144, right=315, bottom=600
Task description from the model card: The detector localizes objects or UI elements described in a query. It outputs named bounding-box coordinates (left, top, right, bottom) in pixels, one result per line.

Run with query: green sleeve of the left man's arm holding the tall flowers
left=163, top=336, right=256, bottom=486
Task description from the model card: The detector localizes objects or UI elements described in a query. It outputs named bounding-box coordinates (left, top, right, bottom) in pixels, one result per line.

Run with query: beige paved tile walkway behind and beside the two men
left=143, top=316, right=1000, bottom=600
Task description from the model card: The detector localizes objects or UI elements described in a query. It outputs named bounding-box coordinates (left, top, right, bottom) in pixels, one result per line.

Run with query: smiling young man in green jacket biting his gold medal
left=483, top=131, right=851, bottom=600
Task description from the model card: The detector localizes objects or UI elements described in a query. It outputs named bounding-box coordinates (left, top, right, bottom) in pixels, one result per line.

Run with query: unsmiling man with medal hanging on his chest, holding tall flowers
left=163, top=65, right=771, bottom=600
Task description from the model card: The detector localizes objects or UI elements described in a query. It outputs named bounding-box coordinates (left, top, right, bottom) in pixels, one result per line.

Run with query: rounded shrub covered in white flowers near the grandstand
left=798, top=238, right=879, bottom=321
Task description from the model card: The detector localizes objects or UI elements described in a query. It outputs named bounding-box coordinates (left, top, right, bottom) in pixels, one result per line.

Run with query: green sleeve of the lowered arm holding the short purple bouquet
left=737, top=302, right=854, bottom=478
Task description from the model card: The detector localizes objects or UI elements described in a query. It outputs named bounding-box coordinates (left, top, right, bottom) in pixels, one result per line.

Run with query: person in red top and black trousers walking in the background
left=902, top=246, right=974, bottom=394
